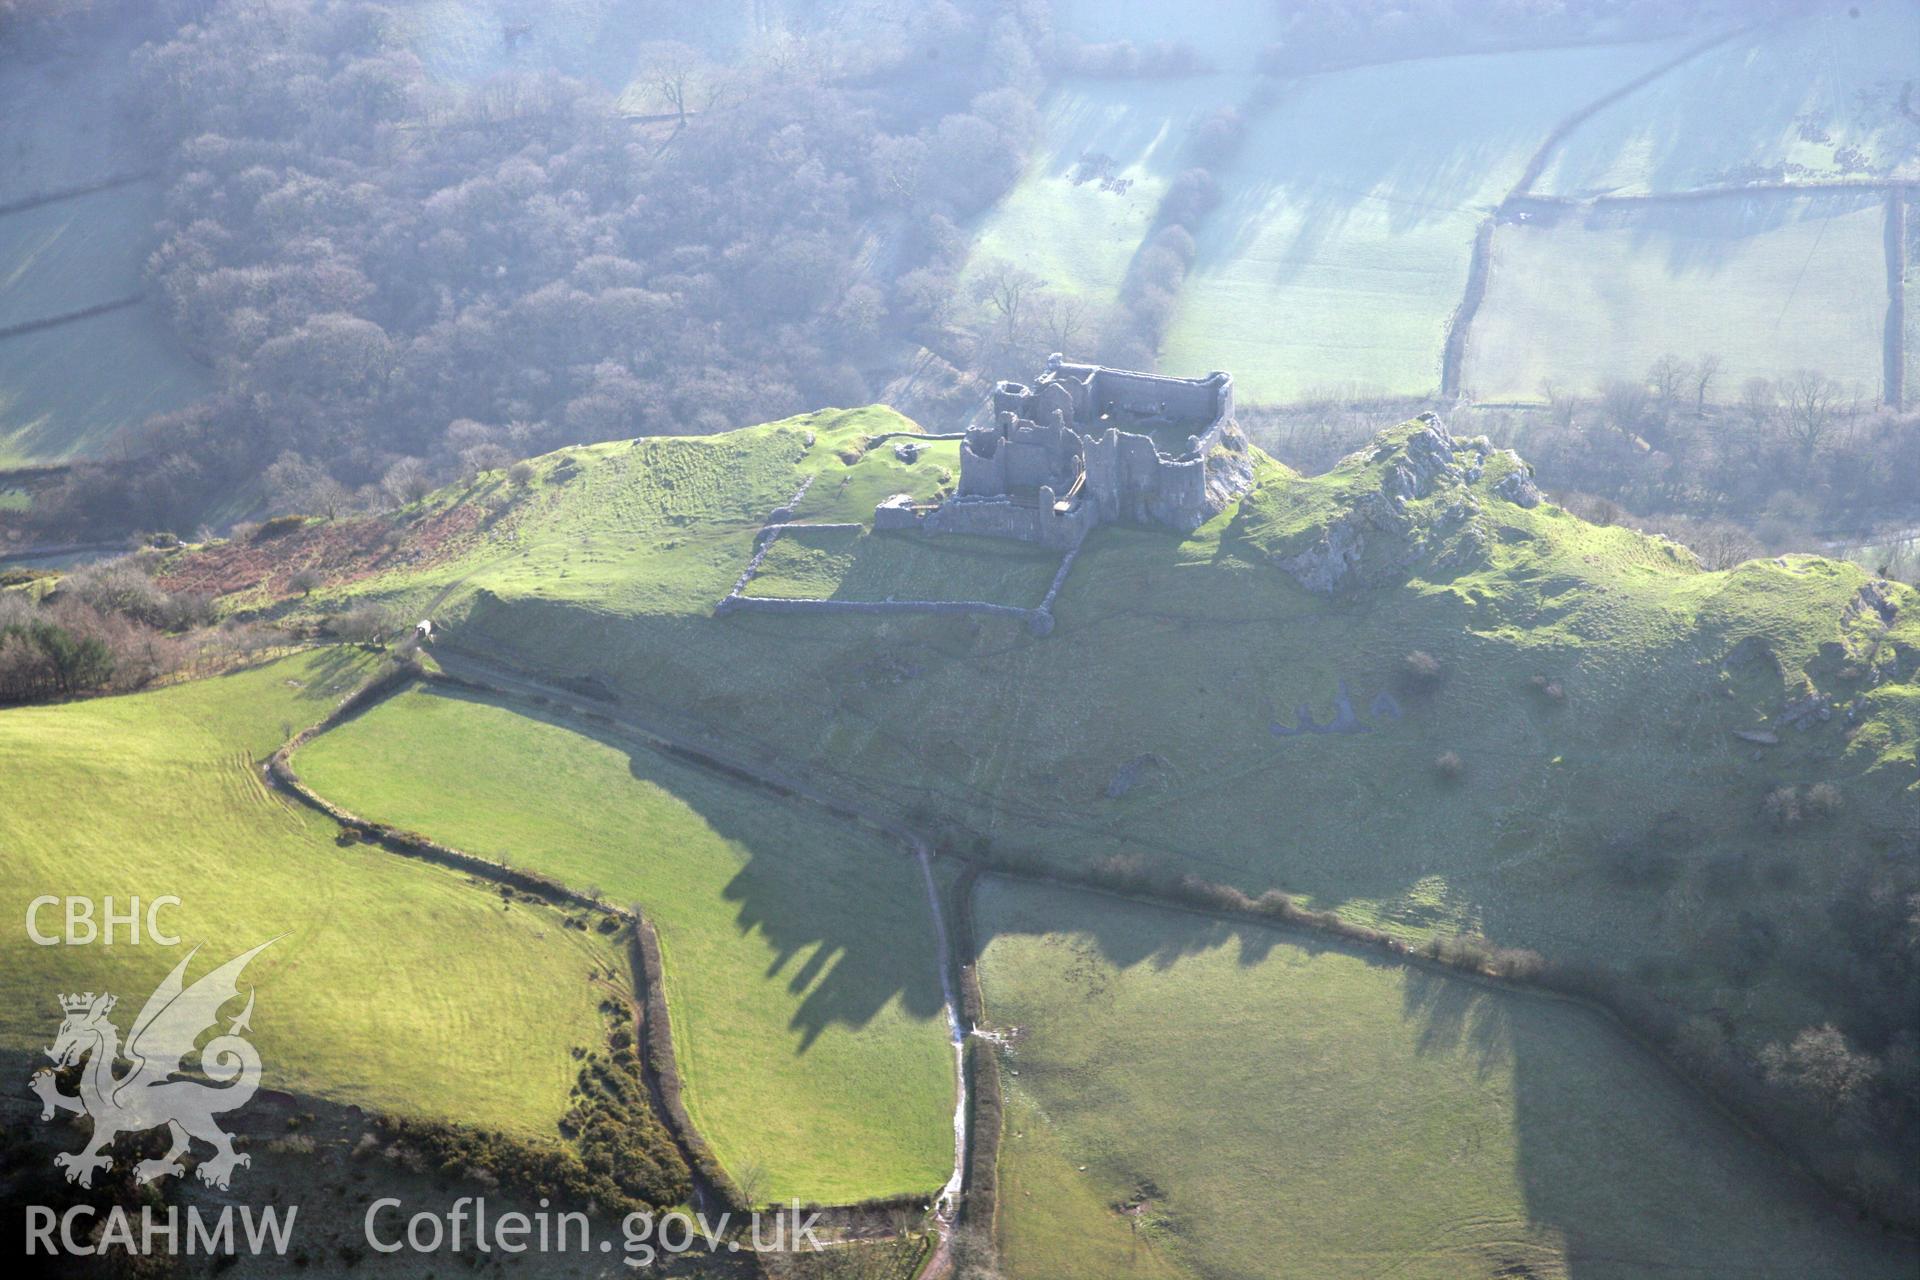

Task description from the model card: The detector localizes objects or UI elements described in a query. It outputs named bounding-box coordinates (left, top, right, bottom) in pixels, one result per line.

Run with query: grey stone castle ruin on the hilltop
left=874, top=355, right=1254, bottom=547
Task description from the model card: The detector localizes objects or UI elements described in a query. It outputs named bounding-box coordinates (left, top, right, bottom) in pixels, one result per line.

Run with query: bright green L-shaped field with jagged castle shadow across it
left=296, top=689, right=954, bottom=1203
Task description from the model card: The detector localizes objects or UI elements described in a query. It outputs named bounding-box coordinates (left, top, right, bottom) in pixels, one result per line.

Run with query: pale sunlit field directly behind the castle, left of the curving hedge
left=1162, top=42, right=1676, bottom=403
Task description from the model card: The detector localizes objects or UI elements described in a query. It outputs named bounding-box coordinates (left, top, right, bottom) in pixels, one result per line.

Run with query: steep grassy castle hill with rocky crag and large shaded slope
left=172, top=411, right=1920, bottom=1113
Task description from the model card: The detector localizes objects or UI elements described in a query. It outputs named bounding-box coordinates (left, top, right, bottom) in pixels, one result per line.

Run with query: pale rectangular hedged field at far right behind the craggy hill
left=1461, top=192, right=1887, bottom=403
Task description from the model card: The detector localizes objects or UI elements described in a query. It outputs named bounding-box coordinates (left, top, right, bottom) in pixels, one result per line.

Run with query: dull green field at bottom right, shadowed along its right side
left=977, top=881, right=1920, bottom=1280
